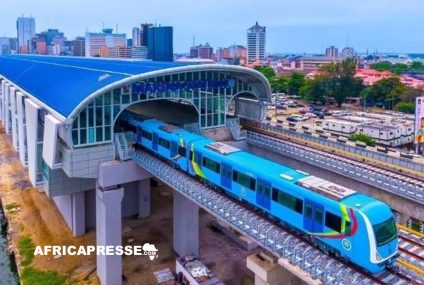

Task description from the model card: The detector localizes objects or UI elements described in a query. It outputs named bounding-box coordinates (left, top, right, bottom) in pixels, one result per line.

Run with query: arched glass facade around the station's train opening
left=71, top=71, right=252, bottom=146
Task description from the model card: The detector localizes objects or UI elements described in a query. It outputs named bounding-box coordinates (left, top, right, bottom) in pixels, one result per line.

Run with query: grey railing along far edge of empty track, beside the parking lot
left=261, top=123, right=424, bottom=172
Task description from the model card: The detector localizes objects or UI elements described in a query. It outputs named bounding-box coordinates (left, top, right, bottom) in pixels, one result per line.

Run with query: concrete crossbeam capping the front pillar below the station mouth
left=98, top=160, right=152, bottom=189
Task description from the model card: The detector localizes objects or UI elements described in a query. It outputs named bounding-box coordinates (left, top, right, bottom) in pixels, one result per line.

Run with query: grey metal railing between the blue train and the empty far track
left=247, top=131, right=424, bottom=205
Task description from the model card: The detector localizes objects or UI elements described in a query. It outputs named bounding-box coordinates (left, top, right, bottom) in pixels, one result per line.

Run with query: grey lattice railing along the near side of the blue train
left=133, top=151, right=414, bottom=285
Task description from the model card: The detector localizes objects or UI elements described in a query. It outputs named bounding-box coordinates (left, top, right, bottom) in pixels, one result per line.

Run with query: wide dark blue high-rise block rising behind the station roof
left=147, top=26, right=174, bottom=61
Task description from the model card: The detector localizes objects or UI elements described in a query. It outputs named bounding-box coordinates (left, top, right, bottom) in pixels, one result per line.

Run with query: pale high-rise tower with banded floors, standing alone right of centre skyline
left=247, top=22, right=266, bottom=62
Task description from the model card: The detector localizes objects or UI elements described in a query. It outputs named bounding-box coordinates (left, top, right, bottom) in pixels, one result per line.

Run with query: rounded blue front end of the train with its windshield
left=341, top=194, right=399, bottom=273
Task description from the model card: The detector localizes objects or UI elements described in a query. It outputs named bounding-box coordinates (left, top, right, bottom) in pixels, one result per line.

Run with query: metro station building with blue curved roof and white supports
left=0, top=55, right=271, bottom=284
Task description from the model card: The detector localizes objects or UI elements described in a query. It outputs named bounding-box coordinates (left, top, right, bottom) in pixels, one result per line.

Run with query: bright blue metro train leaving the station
left=120, top=113, right=399, bottom=273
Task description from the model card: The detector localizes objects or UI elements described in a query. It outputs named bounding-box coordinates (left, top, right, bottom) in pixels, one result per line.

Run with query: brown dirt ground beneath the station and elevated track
left=0, top=125, right=254, bottom=285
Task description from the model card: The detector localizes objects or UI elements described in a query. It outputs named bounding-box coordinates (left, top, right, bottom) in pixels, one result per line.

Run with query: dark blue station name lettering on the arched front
left=132, top=79, right=235, bottom=93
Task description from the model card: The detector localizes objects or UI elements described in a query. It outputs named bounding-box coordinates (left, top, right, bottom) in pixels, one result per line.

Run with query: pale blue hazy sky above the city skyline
left=0, top=0, right=424, bottom=53
